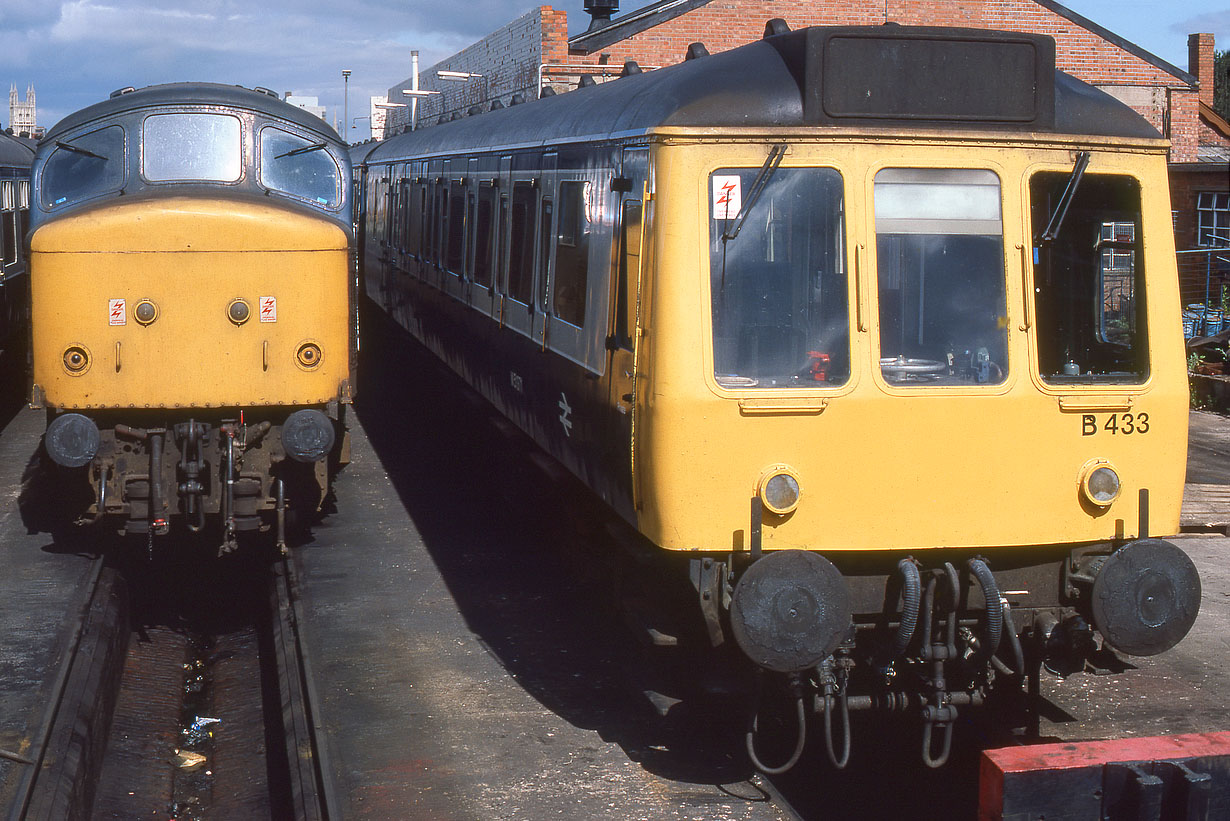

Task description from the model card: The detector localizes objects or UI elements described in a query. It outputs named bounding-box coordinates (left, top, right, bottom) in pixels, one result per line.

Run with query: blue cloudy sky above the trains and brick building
left=0, top=0, right=1230, bottom=139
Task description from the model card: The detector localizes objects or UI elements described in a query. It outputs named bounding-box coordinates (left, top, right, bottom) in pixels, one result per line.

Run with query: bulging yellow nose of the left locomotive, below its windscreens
left=31, top=197, right=349, bottom=409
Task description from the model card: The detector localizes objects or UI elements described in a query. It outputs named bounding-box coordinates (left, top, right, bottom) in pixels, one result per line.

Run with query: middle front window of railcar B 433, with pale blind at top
left=875, top=169, right=1007, bottom=386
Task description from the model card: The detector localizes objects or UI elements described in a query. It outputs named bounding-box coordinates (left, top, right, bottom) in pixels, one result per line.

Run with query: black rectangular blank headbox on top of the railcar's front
left=804, top=26, right=1055, bottom=128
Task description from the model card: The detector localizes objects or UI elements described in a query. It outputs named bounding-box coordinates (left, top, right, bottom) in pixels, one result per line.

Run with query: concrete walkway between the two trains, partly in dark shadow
left=293, top=337, right=786, bottom=821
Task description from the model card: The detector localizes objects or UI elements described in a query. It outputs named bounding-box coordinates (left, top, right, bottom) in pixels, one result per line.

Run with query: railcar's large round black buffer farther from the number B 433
left=731, top=550, right=852, bottom=673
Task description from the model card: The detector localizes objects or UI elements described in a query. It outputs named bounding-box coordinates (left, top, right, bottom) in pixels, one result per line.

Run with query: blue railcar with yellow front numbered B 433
left=355, top=21, right=1200, bottom=772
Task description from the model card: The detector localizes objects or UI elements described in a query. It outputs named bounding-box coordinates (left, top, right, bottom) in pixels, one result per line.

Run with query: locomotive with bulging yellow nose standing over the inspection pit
left=30, top=82, right=357, bottom=550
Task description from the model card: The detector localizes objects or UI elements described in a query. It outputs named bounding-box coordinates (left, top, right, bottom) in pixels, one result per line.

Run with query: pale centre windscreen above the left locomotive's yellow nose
left=141, top=113, right=244, bottom=182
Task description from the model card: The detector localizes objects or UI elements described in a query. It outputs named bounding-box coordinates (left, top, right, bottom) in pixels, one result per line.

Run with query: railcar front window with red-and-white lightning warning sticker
left=708, top=162, right=850, bottom=388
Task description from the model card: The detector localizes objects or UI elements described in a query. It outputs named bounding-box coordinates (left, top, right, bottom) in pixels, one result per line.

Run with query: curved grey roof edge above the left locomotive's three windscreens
left=43, top=82, right=342, bottom=143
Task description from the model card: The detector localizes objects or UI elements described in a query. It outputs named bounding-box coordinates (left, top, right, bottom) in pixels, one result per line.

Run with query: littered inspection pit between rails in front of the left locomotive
left=7, top=539, right=342, bottom=821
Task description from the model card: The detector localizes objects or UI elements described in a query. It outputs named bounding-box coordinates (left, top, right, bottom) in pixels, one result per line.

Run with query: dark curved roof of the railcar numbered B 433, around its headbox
left=364, top=27, right=1160, bottom=162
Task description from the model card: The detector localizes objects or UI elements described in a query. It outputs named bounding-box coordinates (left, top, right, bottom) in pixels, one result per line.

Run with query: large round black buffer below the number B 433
left=1092, top=539, right=1200, bottom=656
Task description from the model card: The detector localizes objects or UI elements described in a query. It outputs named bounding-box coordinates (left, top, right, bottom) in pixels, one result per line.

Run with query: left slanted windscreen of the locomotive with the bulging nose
left=41, top=126, right=124, bottom=209
